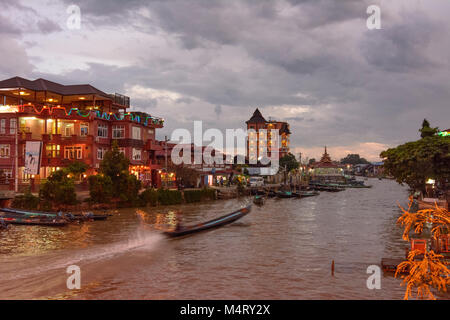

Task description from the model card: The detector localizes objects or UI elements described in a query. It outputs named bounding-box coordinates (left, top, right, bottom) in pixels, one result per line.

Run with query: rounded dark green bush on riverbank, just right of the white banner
left=39, top=169, right=77, bottom=205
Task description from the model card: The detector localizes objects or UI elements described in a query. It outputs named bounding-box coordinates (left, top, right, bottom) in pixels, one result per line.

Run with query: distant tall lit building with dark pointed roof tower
left=246, top=109, right=291, bottom=161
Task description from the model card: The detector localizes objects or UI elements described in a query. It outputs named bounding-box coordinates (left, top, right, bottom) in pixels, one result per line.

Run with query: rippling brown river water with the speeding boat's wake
left=0, top=179, right=449, bottom=299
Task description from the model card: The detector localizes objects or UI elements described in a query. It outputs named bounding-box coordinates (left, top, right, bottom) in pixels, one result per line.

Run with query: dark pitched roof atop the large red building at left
left=0, top=77, right=111, bottom=99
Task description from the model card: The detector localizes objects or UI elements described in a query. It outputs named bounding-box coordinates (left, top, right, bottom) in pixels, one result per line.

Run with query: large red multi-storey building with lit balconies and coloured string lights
left=0, top=77, right=164, bottom=189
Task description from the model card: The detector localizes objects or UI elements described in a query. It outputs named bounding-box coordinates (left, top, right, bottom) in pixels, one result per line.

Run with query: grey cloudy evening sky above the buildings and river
left=0, top=0, right=450, bottom=160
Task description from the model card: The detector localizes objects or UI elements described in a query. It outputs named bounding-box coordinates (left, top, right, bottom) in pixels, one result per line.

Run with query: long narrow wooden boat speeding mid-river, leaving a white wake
left=164, top=205, right=252, bottom=237
